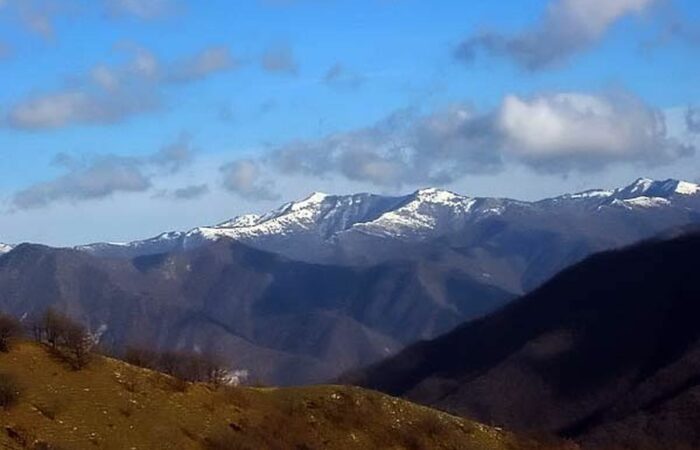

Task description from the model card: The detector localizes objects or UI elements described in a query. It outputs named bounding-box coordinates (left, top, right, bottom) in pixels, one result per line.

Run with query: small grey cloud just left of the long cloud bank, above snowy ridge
left=220, top=159, right=279, bottom=200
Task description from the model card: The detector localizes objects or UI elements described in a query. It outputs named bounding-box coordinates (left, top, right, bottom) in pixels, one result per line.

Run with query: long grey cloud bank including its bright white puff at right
left=231, top=92, right=695, bottom=194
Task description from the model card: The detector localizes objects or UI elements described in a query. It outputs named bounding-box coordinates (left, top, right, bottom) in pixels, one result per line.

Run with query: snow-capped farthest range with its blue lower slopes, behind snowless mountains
left=78, top=178, right=700, bottom=294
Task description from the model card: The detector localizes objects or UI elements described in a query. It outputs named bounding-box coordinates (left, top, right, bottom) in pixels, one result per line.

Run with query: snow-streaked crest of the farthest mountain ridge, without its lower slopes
left=76, top=178, right=700, bottom=256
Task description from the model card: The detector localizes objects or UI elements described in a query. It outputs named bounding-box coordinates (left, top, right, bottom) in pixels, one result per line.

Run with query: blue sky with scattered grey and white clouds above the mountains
left=0, top=0, right=700, bottom=245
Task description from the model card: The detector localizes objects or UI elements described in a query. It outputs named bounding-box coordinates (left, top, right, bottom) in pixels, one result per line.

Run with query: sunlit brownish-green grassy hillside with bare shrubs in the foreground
left=0, top=342, right=576, bottom=450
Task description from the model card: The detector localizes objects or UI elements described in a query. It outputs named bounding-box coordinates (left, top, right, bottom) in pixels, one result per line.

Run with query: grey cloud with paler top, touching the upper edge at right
left=456, top=0, right=659, bottom=70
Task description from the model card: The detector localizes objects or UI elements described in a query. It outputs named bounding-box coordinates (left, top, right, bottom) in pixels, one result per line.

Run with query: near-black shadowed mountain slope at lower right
left=349, top=233, right=700, bottom=449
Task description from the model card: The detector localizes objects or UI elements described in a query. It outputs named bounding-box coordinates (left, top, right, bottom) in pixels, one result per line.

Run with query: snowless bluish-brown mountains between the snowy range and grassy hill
left=0, top=240, right=511, bottom=384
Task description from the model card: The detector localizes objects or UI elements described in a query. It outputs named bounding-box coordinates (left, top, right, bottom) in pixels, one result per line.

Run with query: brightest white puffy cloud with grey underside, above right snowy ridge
left=498, top=93, right=694, bottom=171
